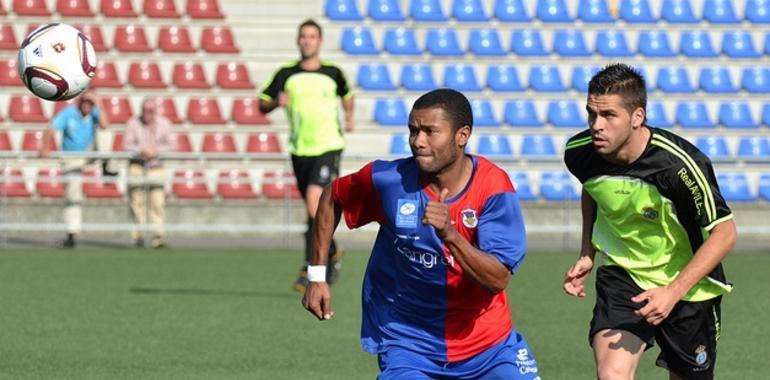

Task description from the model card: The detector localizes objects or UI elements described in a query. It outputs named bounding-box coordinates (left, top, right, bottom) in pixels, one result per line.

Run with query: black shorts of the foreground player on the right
left=588, top=265, right=722, bottom=379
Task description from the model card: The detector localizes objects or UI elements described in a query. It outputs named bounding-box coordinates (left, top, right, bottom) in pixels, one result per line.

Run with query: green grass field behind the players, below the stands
left=0, top=248, right=770, bottom=380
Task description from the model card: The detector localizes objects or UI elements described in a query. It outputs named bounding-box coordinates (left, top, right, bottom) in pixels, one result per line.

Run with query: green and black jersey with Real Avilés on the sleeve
left=564, top=127, right=732, bottom=301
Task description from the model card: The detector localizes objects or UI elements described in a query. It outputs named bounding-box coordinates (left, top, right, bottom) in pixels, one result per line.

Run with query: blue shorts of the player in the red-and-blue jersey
left=377, top=331, right=540, bottom=380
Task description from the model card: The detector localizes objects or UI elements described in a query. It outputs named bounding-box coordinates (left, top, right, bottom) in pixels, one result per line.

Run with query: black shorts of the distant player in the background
left=291, top=150, right=342, bottom=198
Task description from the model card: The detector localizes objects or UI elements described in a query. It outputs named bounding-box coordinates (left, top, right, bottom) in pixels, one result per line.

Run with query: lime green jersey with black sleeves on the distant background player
left=260, top=61, right=353, bottom=156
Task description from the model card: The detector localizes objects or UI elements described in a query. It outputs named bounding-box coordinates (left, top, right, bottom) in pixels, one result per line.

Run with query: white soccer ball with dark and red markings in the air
left=18, top=24, right=96, bottom=101
